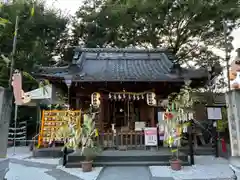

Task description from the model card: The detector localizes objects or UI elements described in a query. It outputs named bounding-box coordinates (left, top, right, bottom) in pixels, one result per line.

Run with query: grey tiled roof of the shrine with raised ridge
left=35, top=48, right=210, bottom=81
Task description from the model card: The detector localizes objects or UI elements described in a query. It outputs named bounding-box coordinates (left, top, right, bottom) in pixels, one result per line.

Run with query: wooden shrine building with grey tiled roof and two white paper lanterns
left=36, top=48, right=218, bottom=149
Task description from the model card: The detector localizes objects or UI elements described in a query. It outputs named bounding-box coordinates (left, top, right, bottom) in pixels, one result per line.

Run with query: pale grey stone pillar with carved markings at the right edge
left=226, top=90, right=240, bottom=156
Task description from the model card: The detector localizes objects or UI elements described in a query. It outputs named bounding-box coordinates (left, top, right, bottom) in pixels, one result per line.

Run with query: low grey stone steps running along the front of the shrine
left=65, top=149, right=189, bottom=168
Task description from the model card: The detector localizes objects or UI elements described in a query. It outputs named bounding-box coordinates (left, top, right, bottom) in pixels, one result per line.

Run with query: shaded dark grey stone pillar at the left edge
left=0, top=87, right=12, bottom=180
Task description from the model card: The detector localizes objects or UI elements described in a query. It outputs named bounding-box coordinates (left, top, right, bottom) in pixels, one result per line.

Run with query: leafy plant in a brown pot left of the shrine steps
left=80, top=113, right=100, bottom=172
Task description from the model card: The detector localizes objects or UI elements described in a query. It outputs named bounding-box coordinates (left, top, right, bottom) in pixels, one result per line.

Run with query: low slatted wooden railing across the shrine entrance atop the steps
left=96, top=131, right=145, bottom=150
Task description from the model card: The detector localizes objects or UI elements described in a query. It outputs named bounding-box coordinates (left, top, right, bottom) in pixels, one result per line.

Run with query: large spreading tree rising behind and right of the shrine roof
left=72, top=0, right=240, bottom=69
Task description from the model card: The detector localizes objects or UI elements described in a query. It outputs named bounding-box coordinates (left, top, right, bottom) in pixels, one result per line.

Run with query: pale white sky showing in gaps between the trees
left=46, top=0, right=240, bottom=57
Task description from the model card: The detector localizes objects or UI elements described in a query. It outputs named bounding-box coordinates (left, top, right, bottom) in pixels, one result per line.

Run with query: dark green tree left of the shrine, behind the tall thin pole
left=0, top=0, right=68, bottom=90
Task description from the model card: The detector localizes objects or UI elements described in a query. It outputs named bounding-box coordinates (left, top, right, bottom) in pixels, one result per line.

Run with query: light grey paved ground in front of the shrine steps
left=6, top=148, right=240, bottom=180
